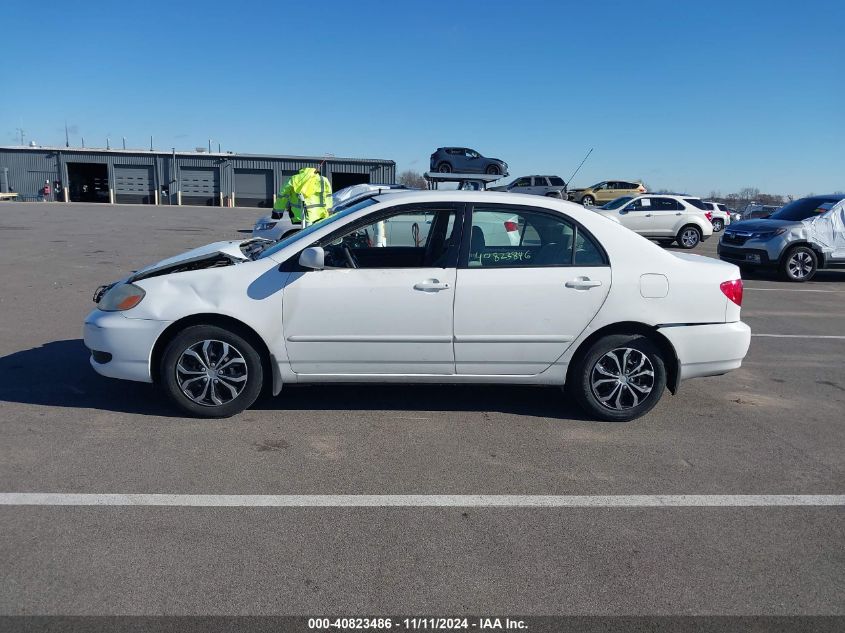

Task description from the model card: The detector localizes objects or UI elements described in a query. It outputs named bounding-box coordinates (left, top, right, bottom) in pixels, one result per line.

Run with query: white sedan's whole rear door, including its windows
left=455, top=204, right=611, bottom=375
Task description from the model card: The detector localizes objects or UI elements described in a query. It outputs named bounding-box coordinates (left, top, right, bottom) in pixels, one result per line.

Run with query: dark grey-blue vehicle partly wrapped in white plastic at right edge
left=718, top=194, right=845, bottom=281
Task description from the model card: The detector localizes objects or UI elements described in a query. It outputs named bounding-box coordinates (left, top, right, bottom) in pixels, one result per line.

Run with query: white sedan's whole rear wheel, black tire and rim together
left=567, top=334, right=666, bottom=422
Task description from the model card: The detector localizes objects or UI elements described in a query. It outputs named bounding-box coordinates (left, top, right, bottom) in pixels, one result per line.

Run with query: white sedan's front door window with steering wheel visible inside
left=316, top=208, right=459, bottom=268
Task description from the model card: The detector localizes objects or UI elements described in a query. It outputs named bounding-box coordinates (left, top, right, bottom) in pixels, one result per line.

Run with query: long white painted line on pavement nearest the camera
left=0, top=492, right=845, bottom=508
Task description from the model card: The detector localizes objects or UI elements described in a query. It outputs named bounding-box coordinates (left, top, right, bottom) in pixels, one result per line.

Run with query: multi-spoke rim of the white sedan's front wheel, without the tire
left=176, top=340, right=248, bottom=407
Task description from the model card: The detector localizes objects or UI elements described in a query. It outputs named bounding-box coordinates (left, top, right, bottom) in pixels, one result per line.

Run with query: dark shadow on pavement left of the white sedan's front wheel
left=0, top=339, right=175, bottom=416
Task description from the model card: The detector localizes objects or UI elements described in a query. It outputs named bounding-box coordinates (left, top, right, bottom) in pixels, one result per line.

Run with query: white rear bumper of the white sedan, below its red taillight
left=658, top=321, right=751, bottom=380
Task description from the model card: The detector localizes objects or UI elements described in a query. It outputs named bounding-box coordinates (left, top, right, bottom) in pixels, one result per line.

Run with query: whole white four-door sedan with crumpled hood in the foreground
left=84, top=191, right=751, bottom=420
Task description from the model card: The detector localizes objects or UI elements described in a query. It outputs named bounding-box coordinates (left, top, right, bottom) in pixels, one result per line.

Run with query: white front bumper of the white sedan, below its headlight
left=82, top=310, right=171, bottom=382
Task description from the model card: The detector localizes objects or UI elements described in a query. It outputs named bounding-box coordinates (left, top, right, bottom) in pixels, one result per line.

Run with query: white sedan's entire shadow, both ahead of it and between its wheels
left=0, top=339, right=588, bottom=420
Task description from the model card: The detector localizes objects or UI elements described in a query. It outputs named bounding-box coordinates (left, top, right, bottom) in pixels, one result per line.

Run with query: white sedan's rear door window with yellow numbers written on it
left=462, top=207, right=576, bottom=268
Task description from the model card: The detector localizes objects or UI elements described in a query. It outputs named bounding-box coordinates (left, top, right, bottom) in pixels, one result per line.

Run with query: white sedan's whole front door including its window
left=283, top=205, right=462, bottom=376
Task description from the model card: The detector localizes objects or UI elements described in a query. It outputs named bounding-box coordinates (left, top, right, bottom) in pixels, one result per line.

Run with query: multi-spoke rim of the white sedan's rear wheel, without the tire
left=590, top=347, right=654, bottom=411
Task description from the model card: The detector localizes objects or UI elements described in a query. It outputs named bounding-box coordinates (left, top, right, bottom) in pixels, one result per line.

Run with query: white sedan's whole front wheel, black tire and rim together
left=159, top=325, right=264, bottom=418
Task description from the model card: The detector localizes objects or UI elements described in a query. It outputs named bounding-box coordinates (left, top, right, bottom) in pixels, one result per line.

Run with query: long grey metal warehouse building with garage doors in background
left=0, top=147, right=396, bottom=207
